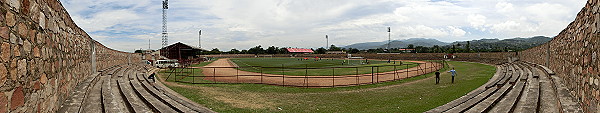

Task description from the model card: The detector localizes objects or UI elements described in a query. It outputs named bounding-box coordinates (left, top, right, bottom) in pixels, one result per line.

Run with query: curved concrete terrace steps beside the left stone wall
left=58, top=64, right=213, bottom=113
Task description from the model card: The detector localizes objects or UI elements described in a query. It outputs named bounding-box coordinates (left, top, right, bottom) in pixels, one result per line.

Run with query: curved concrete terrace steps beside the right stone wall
left=426, top=61, right=583, bottom=113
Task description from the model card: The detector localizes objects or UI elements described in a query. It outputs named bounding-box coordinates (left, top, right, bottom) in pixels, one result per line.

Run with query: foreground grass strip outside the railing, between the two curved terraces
left=159, top=62, right=495, bottom=113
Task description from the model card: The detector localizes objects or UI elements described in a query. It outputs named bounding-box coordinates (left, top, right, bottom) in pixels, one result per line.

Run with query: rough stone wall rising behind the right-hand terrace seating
left=519, top=0, right=600, bottom=112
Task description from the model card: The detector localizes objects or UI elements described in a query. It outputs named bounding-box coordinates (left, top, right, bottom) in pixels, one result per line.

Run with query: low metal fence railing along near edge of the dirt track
left=166, top=61, right=447, bottom=88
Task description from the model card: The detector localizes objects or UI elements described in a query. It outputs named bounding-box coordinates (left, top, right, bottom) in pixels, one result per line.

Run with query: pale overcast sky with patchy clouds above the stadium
left=60, top=0, right=586, bottom=52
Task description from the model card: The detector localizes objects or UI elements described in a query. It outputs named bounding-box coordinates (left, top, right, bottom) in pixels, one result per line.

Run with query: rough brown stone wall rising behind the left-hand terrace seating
left=0, top=0, right=140, bottom=113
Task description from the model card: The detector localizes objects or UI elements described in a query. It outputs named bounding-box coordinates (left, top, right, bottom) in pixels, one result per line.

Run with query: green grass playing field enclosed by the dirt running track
left=231, top=58, right=418, bottom=76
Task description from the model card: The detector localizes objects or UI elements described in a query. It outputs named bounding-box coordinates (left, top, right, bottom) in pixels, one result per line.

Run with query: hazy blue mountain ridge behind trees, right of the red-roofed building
left=344, top=38, right=449, bottom=50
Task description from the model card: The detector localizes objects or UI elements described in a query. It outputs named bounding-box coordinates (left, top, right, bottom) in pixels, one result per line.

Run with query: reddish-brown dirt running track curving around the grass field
left=202, top=58, right=442, bottom=87
